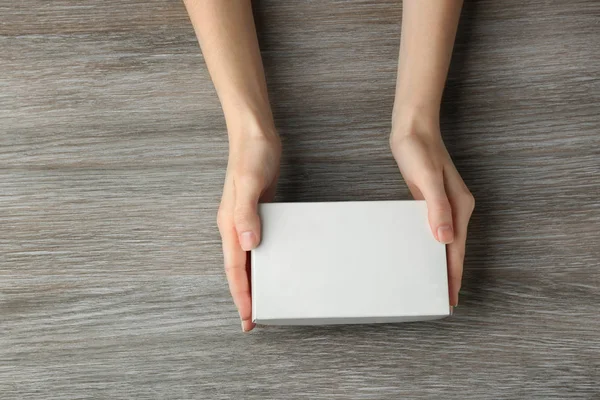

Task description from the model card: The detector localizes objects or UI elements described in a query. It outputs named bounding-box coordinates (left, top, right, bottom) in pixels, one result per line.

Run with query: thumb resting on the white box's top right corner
left=419, top=174, right=454, bottom=244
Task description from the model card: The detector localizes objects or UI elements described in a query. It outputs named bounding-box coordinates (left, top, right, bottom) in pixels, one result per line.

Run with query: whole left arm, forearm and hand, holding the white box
left=184, top=0, right=281, bottom=332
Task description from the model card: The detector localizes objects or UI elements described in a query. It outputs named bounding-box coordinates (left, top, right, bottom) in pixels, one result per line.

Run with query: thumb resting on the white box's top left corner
left=233, top=177, right=262, bottom=251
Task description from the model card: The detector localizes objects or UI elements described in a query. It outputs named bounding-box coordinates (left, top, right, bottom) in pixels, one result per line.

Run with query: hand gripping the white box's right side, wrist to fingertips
left=390, top=118, right=475, bottom=306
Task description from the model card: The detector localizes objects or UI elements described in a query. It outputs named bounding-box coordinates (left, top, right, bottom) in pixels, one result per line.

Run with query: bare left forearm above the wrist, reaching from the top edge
left=184, top=0, right=275, bottom=138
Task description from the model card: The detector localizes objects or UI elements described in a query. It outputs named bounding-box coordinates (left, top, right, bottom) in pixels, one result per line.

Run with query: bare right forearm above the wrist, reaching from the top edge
left=393, top=0, right=463, bottom=124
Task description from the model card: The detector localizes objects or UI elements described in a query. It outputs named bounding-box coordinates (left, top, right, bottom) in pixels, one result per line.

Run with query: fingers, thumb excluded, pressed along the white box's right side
left=444, top=168, right=475, bottom=306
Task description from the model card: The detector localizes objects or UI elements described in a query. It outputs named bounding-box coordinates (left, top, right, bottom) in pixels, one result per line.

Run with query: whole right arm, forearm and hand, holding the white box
left=390, top=0, right=466, bottom=306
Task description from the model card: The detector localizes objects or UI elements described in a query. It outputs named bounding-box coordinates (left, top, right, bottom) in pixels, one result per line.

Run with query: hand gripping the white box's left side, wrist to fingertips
left=217, top=129, right=281, bottom=332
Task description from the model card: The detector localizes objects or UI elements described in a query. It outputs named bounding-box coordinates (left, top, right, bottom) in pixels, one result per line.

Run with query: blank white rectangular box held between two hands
left=251, top=201, right=450, bottom=325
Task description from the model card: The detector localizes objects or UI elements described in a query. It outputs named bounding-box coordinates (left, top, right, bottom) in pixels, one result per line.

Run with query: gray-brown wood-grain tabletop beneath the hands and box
left=0, top=0, right=600, bottom=399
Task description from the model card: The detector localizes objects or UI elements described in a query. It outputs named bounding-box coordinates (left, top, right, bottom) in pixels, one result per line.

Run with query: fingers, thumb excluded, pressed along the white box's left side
left=219, top=212, right=254, bottom=332
